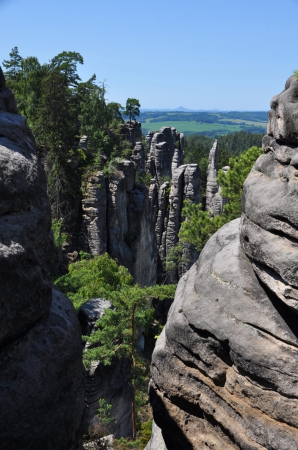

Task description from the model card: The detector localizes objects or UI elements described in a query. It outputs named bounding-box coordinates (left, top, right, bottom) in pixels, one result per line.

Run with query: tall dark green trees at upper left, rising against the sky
left=3, top=47, right=129, bottom=222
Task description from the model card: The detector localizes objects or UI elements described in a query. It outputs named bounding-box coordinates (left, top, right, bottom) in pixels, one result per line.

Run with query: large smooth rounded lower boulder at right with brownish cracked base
left=150, top=220, right=298, bottom=450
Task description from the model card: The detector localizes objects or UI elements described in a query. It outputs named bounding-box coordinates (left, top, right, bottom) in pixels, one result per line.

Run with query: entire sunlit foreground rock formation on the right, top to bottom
left=150, top=77, right=298, bottom=450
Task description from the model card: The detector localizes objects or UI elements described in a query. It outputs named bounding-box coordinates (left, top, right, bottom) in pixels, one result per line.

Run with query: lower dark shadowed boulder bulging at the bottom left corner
left=0, top=289, right=85, bottom=450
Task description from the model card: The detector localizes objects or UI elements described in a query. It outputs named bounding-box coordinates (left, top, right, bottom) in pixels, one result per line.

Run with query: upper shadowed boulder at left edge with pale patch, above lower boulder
left=0, top=82, right=51, bottom=341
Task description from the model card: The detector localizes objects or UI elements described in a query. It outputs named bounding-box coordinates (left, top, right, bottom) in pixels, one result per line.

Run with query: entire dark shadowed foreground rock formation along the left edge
left=0, top=68, right=84, bottom=450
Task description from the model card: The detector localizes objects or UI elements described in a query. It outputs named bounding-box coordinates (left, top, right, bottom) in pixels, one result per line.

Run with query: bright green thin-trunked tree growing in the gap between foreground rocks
left=56, top=254, right=176, bottom=439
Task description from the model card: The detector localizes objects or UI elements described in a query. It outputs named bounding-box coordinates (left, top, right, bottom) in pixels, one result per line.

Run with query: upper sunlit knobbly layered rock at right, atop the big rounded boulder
left=241, top=76, right=298, bottom=312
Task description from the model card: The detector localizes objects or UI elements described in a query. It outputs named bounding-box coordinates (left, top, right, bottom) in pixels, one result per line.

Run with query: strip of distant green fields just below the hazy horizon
left=142, top=119, right=246, bottom=134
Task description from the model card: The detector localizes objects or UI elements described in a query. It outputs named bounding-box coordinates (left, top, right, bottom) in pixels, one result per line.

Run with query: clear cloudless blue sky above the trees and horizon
left=0, top=0, right=298, bottom=110
